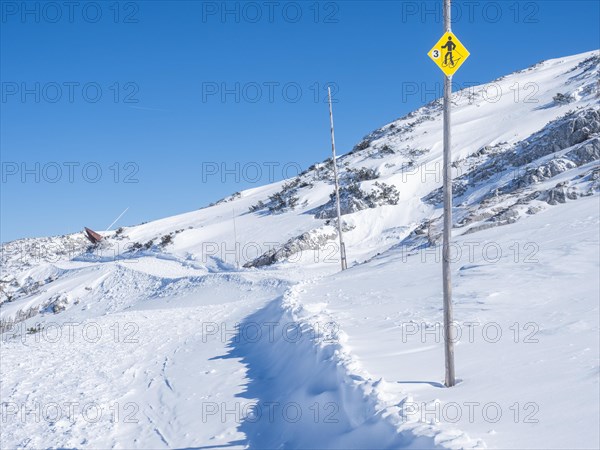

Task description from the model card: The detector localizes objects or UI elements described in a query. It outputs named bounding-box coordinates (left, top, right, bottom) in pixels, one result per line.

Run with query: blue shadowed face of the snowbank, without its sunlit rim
left=220, top=296, right=446, bottom=449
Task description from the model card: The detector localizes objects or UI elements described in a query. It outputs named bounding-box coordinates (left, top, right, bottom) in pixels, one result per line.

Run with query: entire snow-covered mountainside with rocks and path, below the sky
left=0, top=51, right=600, bottom=448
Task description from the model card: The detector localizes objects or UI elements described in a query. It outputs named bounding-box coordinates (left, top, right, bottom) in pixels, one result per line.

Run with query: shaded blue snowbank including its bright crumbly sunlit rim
left=229, top=281, right=485, bottom=449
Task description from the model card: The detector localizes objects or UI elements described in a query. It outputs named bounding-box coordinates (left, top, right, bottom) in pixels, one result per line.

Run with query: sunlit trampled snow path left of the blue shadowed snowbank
left=2, top=273, right=285, bottom=448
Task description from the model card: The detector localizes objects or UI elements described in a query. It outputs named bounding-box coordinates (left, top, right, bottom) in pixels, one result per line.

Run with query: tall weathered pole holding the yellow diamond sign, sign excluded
left=442, top=0, right=456, bottom=387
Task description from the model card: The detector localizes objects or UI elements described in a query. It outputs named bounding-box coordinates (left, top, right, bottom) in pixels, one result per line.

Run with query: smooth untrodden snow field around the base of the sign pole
left=288, top=197, right=600, bottom=449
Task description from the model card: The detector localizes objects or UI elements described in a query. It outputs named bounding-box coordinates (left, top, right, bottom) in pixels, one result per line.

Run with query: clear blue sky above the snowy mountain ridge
left=0, top=0, right=600, bottom=242
